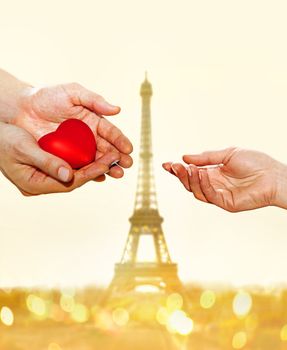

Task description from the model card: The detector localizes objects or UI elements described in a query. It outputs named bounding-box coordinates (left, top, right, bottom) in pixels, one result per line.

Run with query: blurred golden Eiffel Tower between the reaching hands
left=104, top=74, right=186, bottom=304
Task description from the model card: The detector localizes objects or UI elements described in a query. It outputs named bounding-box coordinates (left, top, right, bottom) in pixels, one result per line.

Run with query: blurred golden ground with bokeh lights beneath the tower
left=0, top=288, right=287, bottom=350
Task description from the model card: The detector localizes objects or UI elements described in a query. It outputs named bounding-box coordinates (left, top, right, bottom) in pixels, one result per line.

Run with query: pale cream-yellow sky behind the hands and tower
left=0, top=0, right=287, bottom=286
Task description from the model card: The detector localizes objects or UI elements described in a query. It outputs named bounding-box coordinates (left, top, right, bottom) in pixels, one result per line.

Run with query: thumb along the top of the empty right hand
left=182, top=147, right=236, bottom=166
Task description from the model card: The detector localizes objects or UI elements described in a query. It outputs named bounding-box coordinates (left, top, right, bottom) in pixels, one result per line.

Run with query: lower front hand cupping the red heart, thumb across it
left=0, top=122, right=120, bottom=196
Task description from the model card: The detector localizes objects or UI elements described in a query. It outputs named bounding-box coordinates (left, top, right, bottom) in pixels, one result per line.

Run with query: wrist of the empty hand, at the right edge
left=272, top=162, right=287, bottom=209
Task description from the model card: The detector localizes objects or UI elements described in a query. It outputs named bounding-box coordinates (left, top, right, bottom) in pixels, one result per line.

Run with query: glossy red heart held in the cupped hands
left=38, top=119, right=97, bottom=169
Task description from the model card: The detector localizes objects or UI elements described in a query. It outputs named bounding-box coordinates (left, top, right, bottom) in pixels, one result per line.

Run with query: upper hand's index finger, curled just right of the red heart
left=98, top=118, right=133, bottom=154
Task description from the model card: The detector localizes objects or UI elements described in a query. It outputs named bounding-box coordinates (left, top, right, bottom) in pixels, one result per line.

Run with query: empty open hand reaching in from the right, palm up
left=163, top=147, right=286, bottom=212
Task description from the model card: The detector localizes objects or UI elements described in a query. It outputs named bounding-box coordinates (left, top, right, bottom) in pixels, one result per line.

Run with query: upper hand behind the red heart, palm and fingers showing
left=12, top=83, right=132, bottom=180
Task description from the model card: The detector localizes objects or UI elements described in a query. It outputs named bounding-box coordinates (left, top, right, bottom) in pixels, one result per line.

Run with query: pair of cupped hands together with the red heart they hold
left=0, top=83, right=133, bottom=195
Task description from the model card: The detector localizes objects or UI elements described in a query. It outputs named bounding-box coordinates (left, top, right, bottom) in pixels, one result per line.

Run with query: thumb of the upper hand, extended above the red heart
left=68, top=83, right=121, bottom=115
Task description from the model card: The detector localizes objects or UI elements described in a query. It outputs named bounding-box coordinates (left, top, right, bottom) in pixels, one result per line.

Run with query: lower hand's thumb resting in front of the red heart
left=22, top=142, right=73, bottom=182
